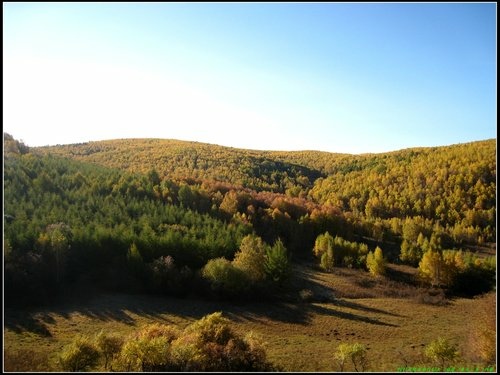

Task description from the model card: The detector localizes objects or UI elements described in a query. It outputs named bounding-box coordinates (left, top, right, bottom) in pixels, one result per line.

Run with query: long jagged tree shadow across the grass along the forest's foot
left=5, top=295, right=398, bottom=337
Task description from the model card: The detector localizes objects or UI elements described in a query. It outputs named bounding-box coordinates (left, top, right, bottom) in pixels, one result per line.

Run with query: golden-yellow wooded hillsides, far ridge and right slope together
left=37, top=139, right=496, bottom=245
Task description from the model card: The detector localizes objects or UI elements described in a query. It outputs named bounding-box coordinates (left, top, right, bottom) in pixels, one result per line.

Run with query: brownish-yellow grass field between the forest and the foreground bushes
left=4, top=266, right=496, bottom=372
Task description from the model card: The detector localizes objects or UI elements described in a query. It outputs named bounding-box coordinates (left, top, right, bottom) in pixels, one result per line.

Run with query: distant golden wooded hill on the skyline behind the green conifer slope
left=38, top=139, right=323, bottom=192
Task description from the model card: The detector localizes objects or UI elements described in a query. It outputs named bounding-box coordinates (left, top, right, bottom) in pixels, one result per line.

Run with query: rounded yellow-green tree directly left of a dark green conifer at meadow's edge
left=233, top=234, right=267, bottom=282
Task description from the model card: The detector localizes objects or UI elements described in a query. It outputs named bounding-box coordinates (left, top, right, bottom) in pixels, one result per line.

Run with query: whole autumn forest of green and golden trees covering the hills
left=3, top=133, right=496, bottom=370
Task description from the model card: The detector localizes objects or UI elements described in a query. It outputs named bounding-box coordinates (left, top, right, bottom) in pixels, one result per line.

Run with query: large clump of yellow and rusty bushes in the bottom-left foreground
left=60, top=312, right=274, bottom=372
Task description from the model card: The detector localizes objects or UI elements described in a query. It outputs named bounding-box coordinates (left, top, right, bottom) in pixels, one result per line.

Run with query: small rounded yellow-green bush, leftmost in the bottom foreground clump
left=59, top=336, right=99, bottom=371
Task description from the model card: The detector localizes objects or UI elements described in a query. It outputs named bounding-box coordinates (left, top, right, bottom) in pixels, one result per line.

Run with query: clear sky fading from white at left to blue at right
left=3, top=2, right=497, bottom=154
